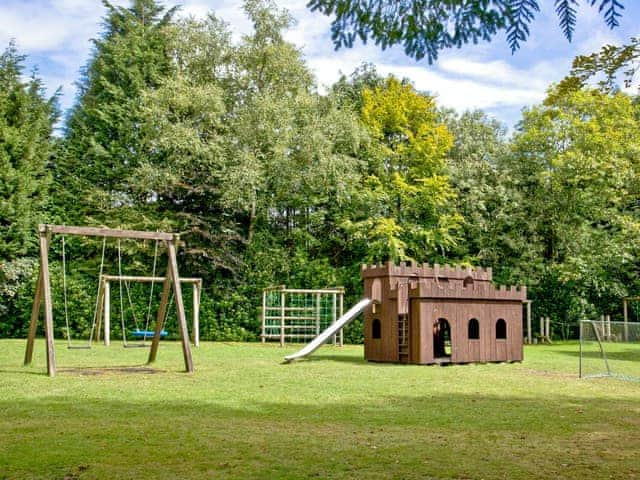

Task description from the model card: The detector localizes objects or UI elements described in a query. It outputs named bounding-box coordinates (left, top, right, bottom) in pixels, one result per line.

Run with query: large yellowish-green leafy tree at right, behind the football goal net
left=496, top=89, right=640, bottom=321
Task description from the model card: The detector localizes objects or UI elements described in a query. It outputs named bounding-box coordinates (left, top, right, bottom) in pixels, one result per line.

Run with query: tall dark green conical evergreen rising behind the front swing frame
left=57, top=0, right=175, bottom=227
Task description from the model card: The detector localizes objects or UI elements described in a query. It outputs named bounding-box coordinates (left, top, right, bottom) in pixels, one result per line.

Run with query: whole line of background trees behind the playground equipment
left=0, top=0, right=640, bottom=342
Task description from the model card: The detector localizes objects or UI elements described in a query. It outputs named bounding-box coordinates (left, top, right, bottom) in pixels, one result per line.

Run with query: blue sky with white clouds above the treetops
left=0, top=0, right=640, bottom=127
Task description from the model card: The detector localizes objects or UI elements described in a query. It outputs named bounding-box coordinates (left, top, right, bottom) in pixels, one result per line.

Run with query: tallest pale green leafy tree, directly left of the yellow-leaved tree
left=218, top=1, right=363, bottom=258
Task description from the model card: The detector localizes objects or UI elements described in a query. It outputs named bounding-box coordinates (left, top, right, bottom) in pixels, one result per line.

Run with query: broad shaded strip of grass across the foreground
left=0, top=388, right=640, bottom=479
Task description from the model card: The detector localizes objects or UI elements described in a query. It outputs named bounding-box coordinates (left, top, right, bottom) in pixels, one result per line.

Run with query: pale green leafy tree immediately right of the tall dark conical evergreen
left=131, top=15, right=242, bottom=275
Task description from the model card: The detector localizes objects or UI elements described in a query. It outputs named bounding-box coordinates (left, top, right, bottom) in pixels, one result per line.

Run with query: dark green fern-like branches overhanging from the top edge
left=308, top=0, right=624, bottom=63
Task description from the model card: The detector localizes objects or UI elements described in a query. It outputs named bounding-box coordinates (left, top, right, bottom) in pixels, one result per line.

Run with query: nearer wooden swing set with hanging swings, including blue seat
left=24, top=225, right=199, bottom=376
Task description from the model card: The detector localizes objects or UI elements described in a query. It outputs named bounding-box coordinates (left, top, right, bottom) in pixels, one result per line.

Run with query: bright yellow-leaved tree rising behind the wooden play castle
left=350, top=77, right=461, bottom=261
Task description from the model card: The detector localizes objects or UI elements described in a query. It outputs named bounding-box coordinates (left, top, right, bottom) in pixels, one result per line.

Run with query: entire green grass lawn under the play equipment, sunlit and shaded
left=0, top=340, right=640, bottom=479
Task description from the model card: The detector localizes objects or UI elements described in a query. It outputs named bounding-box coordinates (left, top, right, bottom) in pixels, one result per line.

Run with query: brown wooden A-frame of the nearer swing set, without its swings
left=24, top=225, right=193, bottom=377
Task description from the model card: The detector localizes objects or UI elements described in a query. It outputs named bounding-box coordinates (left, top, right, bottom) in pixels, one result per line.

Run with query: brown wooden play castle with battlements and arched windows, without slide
left=361, top=263, right=527, bottom=364
